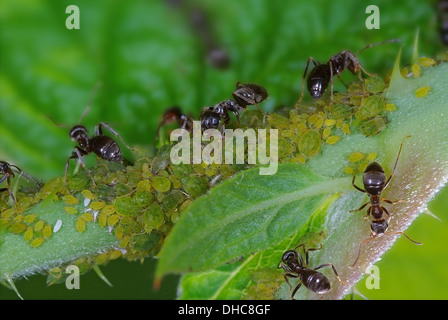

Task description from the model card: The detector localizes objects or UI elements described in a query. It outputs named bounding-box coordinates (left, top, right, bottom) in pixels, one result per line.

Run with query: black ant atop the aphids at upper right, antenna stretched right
left=295, top=39, right=399, bottom=113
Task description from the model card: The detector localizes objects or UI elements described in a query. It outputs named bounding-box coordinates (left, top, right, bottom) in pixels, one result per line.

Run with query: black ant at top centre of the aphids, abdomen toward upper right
left=199, top=82, right=268, bottom=132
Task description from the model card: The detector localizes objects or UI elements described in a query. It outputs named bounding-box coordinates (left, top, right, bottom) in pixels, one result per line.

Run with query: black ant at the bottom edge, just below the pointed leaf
left=277, top=243, right=347, bottom=299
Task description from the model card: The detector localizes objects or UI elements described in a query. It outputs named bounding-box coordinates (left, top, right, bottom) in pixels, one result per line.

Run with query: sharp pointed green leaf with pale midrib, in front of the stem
left=157, top=164, right=350, bottom=277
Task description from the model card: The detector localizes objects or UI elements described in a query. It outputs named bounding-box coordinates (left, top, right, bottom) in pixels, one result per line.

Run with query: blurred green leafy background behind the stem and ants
left=0, top=0, right=448, bottom=299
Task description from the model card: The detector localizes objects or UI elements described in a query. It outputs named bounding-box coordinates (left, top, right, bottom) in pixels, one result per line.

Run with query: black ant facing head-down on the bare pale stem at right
left=350, top=136, right=421, bottom=267
